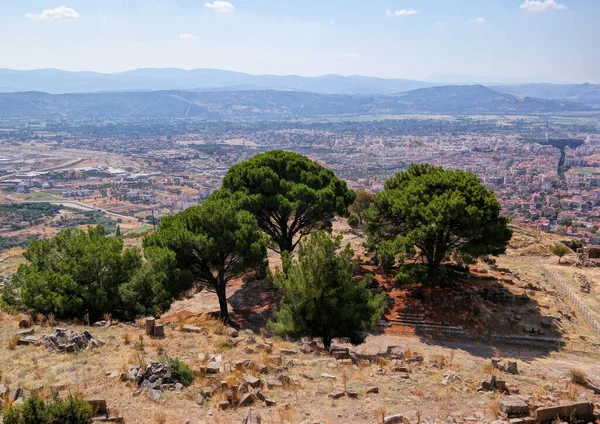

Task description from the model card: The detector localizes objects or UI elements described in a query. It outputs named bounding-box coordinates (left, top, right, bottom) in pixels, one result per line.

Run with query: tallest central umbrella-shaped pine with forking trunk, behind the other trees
left=223, top=150, right=354, bottom=253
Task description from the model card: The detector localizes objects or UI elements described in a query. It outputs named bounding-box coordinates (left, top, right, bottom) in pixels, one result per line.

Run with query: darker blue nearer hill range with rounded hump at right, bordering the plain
left=0, top=85, right=594, bottom=119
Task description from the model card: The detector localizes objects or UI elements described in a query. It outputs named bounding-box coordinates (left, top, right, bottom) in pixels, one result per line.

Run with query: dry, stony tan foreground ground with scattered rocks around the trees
left=0, top=225, right=600, bottom=424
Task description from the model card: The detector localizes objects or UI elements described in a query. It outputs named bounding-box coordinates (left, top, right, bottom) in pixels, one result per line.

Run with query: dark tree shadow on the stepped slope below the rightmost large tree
left=379, top=264, right=564, bottom=361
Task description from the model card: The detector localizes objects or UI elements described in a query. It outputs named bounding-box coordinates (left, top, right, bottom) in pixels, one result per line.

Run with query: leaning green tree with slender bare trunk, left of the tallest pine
left=143, top=192, right=266, bottom=322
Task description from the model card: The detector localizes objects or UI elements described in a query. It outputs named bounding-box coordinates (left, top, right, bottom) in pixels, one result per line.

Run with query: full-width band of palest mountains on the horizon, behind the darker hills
left=0, top=68, right=600, bottom=106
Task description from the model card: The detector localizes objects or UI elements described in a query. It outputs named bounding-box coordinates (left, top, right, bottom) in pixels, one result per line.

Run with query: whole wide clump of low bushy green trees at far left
left=9, top=226, right=193, bottom=320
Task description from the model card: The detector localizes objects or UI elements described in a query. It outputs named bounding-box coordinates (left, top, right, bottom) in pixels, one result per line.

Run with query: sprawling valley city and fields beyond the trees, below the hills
left=0, top=114, right=600, bottom=249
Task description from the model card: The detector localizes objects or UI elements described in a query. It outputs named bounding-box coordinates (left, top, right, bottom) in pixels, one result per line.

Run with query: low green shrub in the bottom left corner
left=4, top=393, right=93, bottom=424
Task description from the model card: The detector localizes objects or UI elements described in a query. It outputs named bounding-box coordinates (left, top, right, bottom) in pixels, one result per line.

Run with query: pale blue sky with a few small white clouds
left=0, top=0, right=600, bottom=82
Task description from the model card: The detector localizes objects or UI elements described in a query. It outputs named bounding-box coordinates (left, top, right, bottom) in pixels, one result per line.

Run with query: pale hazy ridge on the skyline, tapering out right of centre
left=0, top=68, right=432, bottom=94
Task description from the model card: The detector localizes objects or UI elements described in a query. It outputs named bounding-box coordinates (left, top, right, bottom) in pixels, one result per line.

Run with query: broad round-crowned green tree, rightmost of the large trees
left=366, top=164, right=512, bottom=280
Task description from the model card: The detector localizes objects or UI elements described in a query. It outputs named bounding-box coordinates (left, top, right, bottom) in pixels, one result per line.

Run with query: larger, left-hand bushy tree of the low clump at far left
left=11, top=225, right=142, bottom=319
